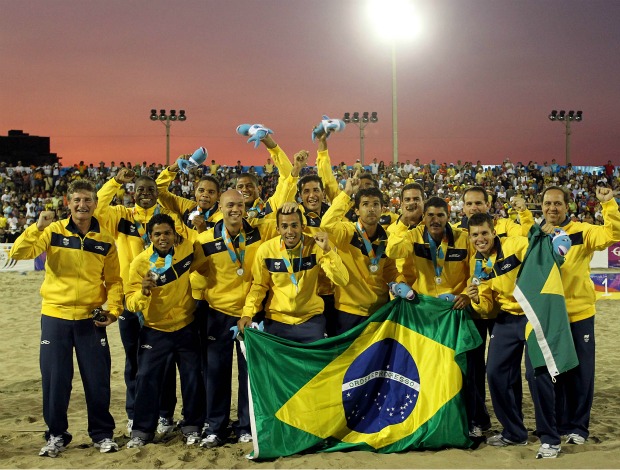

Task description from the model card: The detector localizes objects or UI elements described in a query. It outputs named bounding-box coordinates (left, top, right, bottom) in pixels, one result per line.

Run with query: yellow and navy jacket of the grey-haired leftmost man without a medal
left=9, top=217, right=123, bottom=320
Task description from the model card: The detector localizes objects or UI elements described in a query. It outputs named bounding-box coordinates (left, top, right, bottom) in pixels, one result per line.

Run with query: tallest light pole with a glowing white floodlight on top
left=368, top=0, right=419, bottom=164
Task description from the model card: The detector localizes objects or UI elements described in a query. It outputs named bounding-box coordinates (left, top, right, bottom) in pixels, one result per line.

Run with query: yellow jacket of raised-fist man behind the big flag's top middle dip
left=321, top=191, right=398, bottom=317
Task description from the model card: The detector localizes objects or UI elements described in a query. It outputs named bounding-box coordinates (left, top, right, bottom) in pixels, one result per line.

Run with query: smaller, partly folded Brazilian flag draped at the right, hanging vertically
left=514, top=225, right=579, bottom=377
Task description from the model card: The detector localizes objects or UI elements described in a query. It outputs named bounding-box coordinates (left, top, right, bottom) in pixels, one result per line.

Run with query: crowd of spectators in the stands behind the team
left=0, top=158, right=620, bottom=242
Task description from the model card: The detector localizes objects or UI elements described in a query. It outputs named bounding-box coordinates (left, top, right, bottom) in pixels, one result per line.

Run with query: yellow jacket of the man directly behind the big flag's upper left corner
left=242, top=237, right=349, bottom=325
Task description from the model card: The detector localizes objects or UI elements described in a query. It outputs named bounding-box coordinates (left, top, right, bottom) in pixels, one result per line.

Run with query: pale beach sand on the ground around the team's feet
left=0, top=272, right=620, bottom=468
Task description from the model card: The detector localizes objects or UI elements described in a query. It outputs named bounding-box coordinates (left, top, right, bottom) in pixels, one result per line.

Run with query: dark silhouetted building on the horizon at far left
left=0, top=130, right=58, bottom=166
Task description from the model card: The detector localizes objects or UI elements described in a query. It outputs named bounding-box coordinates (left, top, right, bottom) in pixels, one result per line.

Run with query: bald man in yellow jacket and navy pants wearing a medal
left=193, top=189, right=276, bottom=448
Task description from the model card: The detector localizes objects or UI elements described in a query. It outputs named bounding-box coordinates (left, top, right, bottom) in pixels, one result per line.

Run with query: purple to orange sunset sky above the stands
left=0, top=0, right=620, bottom=169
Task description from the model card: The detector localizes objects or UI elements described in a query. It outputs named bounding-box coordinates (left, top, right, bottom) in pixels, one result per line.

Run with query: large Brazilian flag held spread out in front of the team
left=244, top=295, right=482, bottom=459
